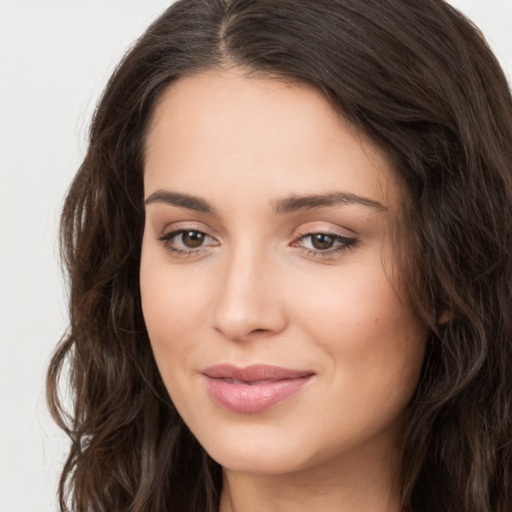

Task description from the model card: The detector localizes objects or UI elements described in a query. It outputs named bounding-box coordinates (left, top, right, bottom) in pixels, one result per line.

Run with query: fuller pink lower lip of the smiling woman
left=206, top=375, right=313, bottom=413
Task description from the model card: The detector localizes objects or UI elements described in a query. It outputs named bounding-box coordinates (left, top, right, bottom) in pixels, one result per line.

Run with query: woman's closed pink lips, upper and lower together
left=203, top=364, right=314, bottom=413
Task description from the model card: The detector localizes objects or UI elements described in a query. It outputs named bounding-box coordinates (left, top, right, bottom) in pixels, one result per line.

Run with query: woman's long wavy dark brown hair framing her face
left=48, top=0, right=512, bottom=512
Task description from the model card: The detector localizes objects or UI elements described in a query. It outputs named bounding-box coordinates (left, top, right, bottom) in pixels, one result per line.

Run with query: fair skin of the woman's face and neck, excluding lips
left=140, top=69, right=425, bottom=512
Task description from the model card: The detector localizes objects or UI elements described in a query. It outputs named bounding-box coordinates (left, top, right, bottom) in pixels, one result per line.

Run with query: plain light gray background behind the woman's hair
left=0, top=0, right=512, bottom=512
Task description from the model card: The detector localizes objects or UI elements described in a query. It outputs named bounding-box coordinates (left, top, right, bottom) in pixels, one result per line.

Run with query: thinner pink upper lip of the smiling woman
left=202, top=364, right=314, bottom=382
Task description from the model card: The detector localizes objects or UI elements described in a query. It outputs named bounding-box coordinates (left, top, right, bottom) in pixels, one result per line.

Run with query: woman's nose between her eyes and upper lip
left=212, top=244, right=287, bottom=340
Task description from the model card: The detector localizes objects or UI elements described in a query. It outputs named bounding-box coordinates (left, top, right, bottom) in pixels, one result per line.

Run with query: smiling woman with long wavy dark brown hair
left=48, top=0, right=512, bottom=512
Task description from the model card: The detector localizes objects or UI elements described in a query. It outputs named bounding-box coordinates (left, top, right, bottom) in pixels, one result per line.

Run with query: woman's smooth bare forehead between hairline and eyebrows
left=145, top=70, right=396, bottom=210
